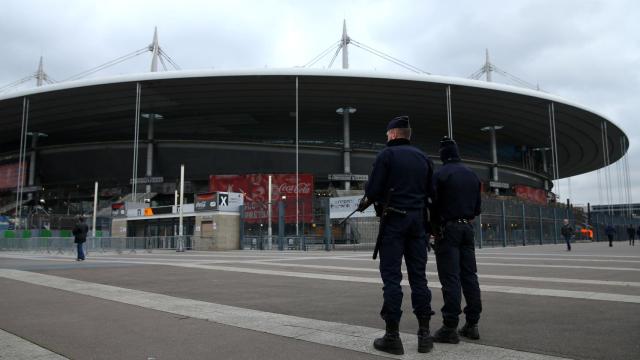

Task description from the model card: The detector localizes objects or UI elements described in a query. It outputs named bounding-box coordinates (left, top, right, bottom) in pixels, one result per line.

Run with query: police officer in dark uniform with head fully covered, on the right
left=433, top=137, right=482, bottom=344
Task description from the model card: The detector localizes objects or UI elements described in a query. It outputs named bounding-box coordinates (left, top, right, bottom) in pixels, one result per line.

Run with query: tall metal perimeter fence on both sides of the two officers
left=241, top=196, right=640, bottom=250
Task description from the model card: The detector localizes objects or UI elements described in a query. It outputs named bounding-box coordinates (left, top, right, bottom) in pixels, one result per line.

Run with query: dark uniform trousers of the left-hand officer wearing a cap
left=380, top=210, right=433, bottom=321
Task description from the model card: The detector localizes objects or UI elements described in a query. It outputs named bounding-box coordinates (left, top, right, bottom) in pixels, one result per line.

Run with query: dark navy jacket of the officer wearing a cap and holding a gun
left=365, top=139, right=433, bottom=210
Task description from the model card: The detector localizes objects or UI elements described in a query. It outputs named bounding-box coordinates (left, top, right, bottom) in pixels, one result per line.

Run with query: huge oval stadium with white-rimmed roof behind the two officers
left=0, top=27, right=628, bottom=245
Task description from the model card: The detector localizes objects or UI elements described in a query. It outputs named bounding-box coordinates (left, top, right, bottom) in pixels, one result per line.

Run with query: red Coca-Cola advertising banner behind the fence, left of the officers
left=209, top=174, right=313, bottom=224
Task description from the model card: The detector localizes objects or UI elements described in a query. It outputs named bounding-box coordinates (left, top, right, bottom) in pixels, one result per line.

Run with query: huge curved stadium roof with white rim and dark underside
left=0, top=68, right=628, bottom=177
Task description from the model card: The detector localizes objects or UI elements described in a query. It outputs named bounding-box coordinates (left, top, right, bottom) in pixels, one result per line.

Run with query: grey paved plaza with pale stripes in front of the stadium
left=0, top=242, right=640, bottom=360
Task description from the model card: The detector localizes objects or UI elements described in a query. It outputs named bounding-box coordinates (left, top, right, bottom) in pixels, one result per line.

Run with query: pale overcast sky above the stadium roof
left=0, top=0, right=640, bottom=204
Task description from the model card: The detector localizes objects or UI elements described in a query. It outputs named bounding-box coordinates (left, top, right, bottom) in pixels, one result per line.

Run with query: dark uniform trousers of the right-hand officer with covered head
left=435, top=222, right=482, bottom=327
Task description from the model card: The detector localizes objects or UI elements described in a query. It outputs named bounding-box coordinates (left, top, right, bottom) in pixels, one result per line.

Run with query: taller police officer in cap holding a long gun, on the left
left=358, top=116, right=434, bottom=355
